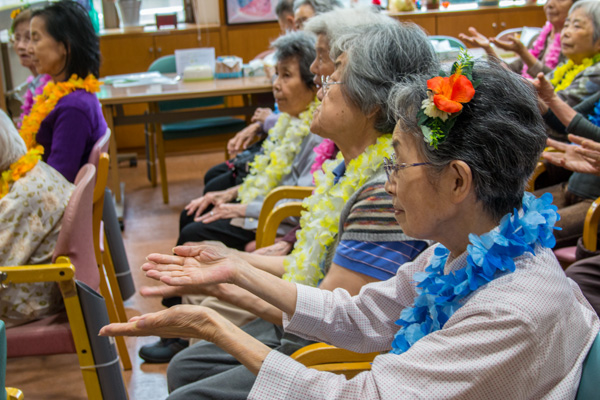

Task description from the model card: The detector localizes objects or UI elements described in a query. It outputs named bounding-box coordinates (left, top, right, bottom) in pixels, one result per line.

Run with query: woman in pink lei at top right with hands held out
left=458, top=0, right=575, bottom=78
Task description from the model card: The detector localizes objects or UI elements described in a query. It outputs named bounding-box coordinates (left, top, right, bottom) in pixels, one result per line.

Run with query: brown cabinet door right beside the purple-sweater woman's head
left=100, top=35, right=154, bottom=76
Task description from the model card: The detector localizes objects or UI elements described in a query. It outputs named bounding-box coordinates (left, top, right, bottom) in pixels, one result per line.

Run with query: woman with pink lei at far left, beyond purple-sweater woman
left=10, top=7, right=52, bottom=126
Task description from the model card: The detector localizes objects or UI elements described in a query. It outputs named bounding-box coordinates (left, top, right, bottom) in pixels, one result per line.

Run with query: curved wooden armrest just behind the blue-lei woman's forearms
left=291, top=343, right=381, bottom=367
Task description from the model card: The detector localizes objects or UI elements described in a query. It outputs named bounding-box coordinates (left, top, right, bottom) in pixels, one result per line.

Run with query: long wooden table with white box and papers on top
left=98, top=77, right=272, bottom=216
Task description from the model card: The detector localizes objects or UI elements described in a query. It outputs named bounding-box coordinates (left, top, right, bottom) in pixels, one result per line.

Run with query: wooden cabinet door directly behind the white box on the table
left=154, top=31, right=221, bottom=58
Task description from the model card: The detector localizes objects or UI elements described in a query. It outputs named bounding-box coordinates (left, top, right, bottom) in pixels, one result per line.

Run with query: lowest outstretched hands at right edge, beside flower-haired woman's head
left=542, top=135, right=600, bottom=176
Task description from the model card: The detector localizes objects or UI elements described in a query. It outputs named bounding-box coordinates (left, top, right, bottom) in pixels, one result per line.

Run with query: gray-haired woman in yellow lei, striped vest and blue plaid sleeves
left=132, top=21, right=438, bottom=399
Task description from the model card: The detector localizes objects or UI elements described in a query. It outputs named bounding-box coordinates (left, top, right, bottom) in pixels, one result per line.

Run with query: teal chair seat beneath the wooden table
left=162, top=117, right=246, bottom=140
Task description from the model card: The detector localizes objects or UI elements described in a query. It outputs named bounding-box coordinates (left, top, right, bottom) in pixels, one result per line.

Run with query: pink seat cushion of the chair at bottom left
left=6, top=312, right=76, bottom=357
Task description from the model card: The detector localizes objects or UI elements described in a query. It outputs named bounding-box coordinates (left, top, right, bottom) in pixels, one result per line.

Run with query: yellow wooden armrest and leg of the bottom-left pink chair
left=0, top=257, right=102, bottom=399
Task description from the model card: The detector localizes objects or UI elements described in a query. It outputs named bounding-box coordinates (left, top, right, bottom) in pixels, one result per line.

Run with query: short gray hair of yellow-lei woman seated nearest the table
left=271, top=31, right=317, bottom=89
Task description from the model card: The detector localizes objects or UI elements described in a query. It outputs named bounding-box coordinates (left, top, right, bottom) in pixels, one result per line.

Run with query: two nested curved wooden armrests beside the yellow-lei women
left=256, top=186, right=315, bottom=249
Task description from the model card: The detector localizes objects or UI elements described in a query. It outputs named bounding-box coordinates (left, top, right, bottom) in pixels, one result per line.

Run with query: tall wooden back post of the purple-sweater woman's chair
left=92, top=153, right=131, bottom=370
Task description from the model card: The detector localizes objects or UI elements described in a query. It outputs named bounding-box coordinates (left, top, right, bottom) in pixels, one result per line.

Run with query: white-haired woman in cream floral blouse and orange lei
left=0, top=111, right=74, bottom=327
